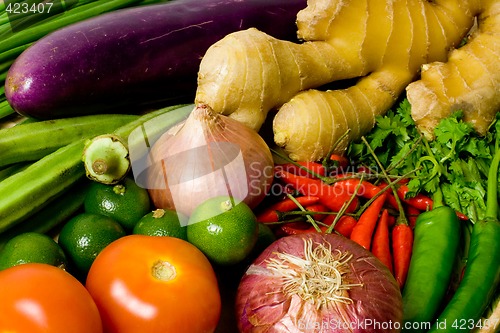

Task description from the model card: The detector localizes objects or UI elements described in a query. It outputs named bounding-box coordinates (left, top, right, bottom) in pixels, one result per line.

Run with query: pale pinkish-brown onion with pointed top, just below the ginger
left=147, top=105, right=273, bottom=215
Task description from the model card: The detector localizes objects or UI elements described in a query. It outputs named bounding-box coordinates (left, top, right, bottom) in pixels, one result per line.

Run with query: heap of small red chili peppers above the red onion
left=257, top=156, right=418, bottom=288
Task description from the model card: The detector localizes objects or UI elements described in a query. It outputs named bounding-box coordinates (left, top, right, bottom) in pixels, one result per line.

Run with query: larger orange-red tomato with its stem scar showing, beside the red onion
left=86, top=235, right=221, bottom=333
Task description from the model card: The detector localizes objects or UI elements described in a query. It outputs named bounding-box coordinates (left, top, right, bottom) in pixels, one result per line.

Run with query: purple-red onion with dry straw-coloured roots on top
left=236, top=233, right=403, bottom=333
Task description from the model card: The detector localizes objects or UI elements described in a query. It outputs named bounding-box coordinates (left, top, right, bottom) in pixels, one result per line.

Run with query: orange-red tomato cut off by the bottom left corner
left=0, top=263, right=102, bottom=333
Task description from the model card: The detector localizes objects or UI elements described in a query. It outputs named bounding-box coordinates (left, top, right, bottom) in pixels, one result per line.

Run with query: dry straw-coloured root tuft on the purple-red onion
left=266, top=239, right=362, bottom=309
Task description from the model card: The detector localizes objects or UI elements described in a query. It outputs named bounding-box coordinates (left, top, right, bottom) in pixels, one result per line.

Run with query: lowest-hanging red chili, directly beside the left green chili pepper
left=392, top=221, right=413, bottom=288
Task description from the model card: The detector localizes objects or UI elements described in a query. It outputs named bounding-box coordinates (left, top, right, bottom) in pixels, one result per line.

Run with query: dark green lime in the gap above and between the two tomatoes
left=58, top=213, right=126, bottom=275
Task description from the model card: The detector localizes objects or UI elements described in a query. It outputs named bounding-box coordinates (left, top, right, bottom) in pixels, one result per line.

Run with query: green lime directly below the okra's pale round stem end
left=84, top=178, right=151, bottom=231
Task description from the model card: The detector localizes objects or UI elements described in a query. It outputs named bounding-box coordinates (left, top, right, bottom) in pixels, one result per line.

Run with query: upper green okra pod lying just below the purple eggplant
left=0, top=114, right=139, bottom=167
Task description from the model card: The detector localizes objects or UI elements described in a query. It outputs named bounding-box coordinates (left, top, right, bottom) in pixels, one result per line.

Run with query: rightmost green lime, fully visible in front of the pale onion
left=187, top=196, right=258, bottom=265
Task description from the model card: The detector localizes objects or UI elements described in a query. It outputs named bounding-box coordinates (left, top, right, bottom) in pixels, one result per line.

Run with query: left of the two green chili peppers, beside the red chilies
left=403, top=191, right=461, bottom=332
